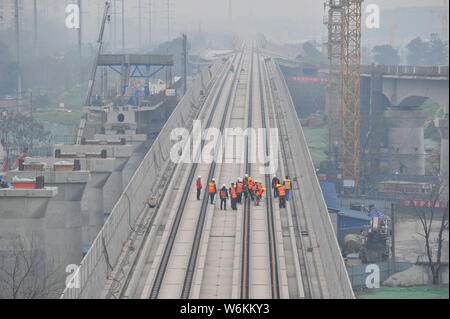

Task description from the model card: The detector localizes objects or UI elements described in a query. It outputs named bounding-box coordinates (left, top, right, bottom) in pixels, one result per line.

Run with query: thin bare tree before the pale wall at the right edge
left=405, top=177, right=449, bottom=285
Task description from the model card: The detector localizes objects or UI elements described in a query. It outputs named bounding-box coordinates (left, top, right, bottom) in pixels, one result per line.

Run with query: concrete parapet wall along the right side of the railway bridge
left=276, top=60, right=355, bottom=299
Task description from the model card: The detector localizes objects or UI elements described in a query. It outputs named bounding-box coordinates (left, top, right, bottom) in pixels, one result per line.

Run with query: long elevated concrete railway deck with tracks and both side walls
left=62, top=43, right=354, bottom=299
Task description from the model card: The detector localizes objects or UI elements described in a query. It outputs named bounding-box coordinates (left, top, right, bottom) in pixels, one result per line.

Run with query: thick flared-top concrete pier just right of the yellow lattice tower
left=384, top=107, right=427, bottom=175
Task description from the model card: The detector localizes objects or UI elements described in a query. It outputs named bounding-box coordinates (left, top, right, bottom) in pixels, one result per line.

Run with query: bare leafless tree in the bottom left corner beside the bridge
left=0, top=235, right=61, bottom=299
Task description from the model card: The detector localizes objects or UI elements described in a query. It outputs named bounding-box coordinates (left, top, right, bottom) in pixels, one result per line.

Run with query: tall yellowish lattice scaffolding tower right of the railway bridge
left=325, top=0, right=363, bottom=191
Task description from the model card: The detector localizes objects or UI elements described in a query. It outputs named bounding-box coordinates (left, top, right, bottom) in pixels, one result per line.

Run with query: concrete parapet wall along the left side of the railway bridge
left=61, top=60, right=222, bottom=299
